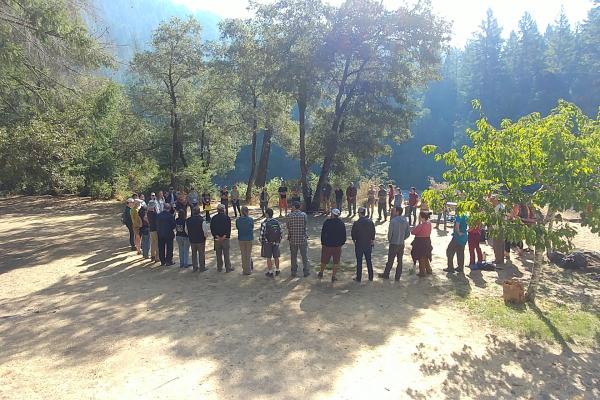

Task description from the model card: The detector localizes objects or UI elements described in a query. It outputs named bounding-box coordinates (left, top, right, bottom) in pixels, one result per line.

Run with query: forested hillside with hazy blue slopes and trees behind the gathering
left=0, top=0, right=600, bottom=199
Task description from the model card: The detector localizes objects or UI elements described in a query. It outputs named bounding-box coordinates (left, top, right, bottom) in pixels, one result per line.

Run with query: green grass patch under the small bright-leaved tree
left=458, top=296, right=600, bottom=347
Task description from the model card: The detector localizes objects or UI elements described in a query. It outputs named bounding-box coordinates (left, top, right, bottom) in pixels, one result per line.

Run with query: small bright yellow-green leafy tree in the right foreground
left=424, top=101, right=600, bottom=301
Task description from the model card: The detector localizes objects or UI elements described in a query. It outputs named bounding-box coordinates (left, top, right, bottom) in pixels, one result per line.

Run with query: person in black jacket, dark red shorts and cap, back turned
left=318, top=208, right=346, bottom=282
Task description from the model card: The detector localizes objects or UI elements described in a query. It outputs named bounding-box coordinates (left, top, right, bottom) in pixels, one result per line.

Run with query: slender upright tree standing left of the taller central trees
left=131, top=17, right=203, bottom=185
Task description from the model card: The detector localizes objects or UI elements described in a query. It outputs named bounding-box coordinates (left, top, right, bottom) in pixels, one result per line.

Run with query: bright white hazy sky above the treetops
left=172, top=0, right=592, bottom=45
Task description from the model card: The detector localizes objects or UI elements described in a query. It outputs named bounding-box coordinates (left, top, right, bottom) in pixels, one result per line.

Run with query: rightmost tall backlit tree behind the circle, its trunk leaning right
left=313, top=0, right=447, bottom=204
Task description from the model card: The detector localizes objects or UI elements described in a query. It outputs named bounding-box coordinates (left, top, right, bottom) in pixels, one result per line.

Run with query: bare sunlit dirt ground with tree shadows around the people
left=0, top=197, right=600, bottom=399
